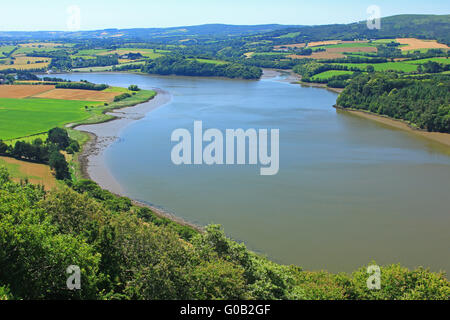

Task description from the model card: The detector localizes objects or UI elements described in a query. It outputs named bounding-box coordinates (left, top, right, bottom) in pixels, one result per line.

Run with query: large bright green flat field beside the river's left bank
left=0, top=98, right=99, bottom=140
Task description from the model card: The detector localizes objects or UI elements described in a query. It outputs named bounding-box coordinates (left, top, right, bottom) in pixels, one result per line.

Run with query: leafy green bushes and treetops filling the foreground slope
left=0, top=168, right=450, bottom=300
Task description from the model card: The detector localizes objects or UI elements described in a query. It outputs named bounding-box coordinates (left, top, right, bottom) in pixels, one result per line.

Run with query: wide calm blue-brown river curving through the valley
left=53, top=73, right=450, bottom=272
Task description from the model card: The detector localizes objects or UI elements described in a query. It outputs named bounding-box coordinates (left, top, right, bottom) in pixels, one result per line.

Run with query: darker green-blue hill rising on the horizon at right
left=261, top=14, right=450, bottom=45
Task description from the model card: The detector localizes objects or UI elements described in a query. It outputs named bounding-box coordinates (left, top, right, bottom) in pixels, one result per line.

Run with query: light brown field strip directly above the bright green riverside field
left=33, top=89, right=120, bottom=102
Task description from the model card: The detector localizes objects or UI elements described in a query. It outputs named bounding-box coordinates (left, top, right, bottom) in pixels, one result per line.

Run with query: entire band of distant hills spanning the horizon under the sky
left=0, top=14, right=450, bottom=45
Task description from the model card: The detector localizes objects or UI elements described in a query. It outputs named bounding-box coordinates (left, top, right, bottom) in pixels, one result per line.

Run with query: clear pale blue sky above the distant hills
left=0, top=0, right=450, bottom=31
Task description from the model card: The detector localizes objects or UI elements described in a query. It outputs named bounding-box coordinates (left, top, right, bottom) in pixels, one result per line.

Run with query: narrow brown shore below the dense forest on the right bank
left=337, top=107, right=450, bottom=147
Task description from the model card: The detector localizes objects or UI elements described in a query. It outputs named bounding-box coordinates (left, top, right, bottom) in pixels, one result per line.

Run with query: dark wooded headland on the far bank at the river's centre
left=142, top=56, right=262, bottom=79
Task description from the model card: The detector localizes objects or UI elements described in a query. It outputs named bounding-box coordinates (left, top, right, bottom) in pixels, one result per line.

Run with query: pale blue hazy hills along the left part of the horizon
left=0, top=24, right=301, bottom=40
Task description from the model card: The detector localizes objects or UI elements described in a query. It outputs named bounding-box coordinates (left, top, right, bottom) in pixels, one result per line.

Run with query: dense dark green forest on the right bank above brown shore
left=337, top=73, right=450, bottom=133
